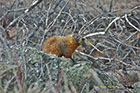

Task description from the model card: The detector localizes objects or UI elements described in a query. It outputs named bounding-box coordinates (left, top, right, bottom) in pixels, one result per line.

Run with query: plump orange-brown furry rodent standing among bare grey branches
left=42, top=34, right=80, bottom=59
